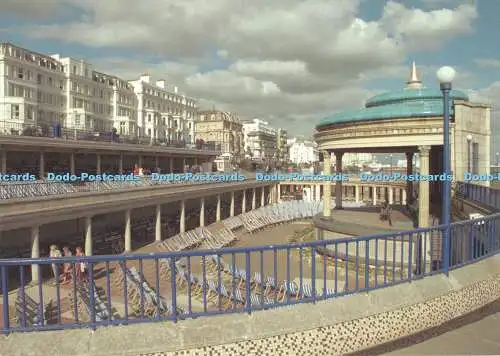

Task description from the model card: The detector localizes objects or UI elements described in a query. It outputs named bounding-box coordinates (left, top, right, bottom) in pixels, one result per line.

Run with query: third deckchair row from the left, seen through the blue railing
left=115, top=264, right=170, bottom=318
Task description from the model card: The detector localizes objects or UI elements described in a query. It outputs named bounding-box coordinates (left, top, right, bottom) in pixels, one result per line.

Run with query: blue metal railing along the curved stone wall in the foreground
left=0, top=184, right=500, bottom=334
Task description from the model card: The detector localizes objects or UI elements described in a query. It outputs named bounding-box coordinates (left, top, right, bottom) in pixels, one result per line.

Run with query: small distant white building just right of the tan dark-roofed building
left=243, top=119, right=277, bottom=160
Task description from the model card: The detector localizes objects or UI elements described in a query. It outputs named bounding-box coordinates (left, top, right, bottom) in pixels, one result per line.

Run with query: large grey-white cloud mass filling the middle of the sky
left=5, top=0, right=477, bottom=132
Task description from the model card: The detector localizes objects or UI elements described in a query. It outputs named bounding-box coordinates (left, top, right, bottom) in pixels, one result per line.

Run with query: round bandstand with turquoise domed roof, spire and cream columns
left=315, top=63, right=491, bottom=227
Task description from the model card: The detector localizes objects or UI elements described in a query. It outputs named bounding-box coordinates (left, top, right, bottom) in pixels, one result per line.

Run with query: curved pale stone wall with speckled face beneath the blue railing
left=0, top=255, right=500, bottom=356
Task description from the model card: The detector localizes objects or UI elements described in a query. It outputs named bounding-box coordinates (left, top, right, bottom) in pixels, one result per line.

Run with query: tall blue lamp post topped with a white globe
left=436, top=66, right=455, bottom=275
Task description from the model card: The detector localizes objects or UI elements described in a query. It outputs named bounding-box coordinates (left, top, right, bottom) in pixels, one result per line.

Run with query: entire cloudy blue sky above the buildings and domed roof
left=0, top=0, right=500, bottom=143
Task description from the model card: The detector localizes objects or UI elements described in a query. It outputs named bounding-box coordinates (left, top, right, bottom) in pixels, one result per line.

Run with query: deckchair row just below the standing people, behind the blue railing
left=69, top=281, right=112, bottom=322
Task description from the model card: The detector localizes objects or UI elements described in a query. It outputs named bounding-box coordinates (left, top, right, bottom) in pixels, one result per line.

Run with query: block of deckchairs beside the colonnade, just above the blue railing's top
left=156, top=227, right=238, bottom=252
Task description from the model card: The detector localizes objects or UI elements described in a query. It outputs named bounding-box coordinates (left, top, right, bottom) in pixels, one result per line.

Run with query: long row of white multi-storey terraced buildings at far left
left=0, top=43, right=196, bottom=143
